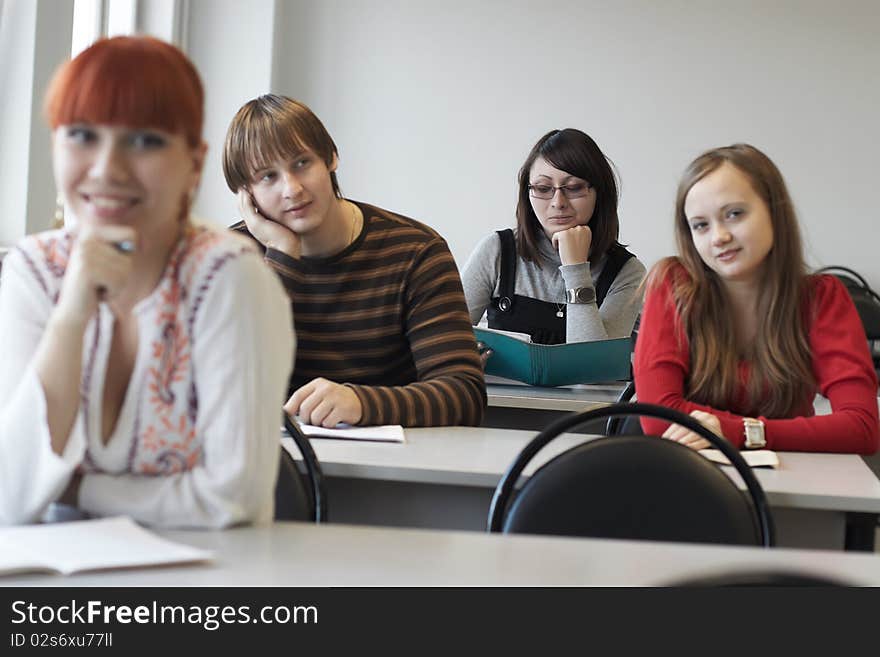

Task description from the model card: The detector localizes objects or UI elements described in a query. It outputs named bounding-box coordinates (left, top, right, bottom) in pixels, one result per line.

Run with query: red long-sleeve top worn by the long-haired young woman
left=633, top=268, right=880, bottom=454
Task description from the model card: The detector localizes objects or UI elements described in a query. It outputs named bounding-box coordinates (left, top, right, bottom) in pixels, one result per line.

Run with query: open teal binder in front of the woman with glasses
left=474, top=327, right=632, bottom=386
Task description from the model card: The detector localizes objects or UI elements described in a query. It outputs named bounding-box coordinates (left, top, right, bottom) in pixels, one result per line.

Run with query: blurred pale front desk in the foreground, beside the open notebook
left=6, top=523, right=880, bottom=587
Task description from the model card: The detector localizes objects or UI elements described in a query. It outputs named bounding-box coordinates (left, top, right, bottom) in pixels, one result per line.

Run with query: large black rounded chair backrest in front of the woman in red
left=488, top=403, right=774, bottom=547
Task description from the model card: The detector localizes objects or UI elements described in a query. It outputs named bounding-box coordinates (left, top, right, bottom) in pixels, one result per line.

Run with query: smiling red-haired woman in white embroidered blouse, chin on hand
left=0, top=37, right=293, bottom=527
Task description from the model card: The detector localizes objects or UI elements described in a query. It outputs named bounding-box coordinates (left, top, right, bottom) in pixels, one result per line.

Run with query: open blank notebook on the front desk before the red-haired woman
left=0, top=517, right=212, bottom=575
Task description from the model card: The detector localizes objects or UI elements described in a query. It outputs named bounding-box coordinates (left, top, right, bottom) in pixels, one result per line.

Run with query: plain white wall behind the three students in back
left=217, top=0, right=880, bottom=287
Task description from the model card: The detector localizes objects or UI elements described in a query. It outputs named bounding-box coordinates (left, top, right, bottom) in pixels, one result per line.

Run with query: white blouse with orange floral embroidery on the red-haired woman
left=0, top=224, right=294, bottom=527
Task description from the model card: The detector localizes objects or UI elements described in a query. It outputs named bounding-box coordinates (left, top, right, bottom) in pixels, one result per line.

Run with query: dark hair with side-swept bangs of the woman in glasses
left=516, top=128, right=620, bottom=265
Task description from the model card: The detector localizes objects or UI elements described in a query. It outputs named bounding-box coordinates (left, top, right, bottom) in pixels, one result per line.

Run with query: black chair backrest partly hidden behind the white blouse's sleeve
left=275, top=413, right=327, bottom=523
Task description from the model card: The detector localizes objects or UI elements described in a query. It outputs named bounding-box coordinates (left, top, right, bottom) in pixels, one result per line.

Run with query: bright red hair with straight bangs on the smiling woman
left=44, top=36, right=205, bottom=147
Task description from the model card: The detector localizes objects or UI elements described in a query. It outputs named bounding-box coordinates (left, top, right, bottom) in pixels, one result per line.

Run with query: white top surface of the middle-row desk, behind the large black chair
left=283, top=427, right=880, bottom=513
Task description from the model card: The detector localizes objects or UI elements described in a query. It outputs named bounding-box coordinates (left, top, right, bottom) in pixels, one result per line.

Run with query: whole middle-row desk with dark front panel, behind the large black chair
left=283, top=427, right=880, bottom=551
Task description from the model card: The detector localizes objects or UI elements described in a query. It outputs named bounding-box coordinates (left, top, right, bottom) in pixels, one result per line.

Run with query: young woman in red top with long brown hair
left=634, top=144, right=880, bottom=454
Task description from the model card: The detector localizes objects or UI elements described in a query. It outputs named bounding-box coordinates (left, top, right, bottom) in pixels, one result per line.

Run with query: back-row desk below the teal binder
left=486, top=376, right=626, bottom=411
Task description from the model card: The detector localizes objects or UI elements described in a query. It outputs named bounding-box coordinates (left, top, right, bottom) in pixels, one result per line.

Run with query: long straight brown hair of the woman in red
left=648, top=144, right=815, bottom=417
